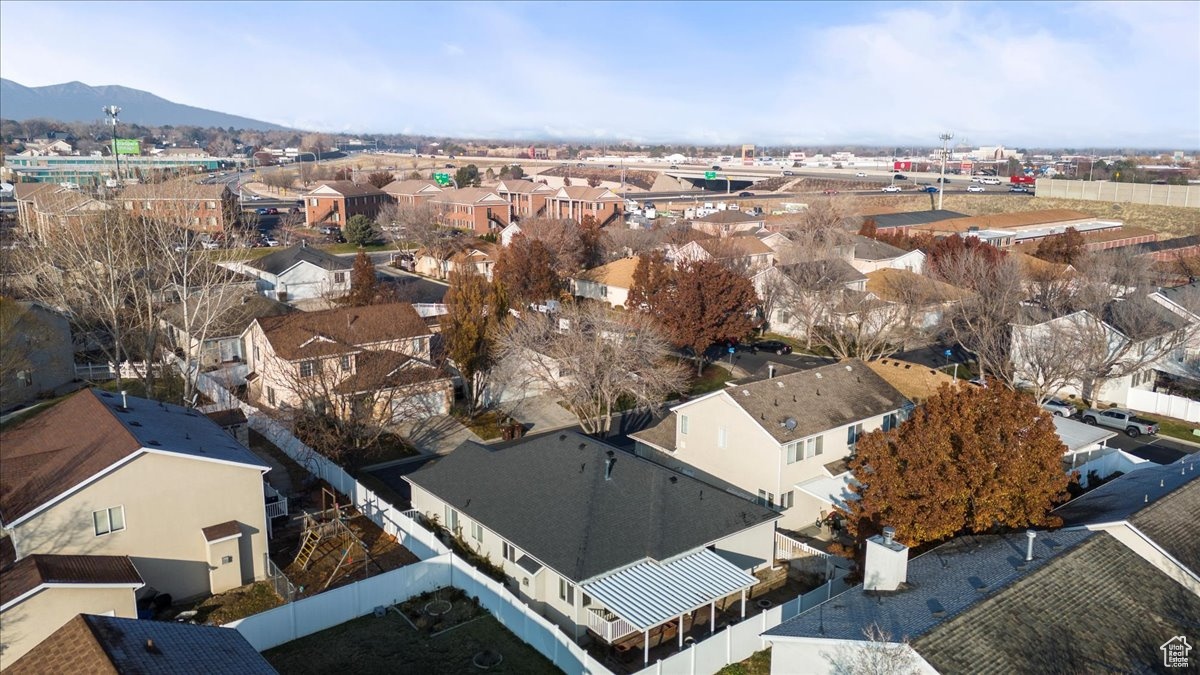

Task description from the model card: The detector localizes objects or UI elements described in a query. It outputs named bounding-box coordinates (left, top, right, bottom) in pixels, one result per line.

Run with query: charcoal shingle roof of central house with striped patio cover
left=406, top=431, right=779, bottom=581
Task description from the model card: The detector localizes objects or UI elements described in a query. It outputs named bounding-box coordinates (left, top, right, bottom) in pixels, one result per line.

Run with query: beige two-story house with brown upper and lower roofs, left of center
left=242, top=303, right=454, bottom=420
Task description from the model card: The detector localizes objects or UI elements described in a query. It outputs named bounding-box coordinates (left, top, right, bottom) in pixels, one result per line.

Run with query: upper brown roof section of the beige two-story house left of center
left=256, top=303, right=431, bottom=360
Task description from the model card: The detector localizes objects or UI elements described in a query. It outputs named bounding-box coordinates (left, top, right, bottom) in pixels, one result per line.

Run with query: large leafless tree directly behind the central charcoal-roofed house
left=496, top=304, right=686, bottom=435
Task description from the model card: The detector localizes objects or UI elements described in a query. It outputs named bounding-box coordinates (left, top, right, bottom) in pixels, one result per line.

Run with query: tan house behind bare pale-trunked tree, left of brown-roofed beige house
left=162, top=289, right=294, bottom=368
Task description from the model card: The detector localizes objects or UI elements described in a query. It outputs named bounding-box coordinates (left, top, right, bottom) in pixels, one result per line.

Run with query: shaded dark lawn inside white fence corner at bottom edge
left=263, top=593, right=560, bottom=675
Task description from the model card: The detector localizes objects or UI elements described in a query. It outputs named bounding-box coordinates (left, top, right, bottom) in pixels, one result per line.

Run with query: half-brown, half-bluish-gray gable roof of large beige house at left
left=0, top=389, right=266, bottom=524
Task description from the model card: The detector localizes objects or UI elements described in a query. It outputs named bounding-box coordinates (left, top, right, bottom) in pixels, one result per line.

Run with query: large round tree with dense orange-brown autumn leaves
left=844, top=382, right=1074, bottom=550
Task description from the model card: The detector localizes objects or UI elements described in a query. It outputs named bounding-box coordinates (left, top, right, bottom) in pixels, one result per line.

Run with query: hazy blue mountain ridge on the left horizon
left=0, top=78, right=287, bottom=131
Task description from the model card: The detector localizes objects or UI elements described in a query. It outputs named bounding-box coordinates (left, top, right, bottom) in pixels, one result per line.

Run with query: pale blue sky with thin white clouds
left=0, top=1, right=1200, bottom=150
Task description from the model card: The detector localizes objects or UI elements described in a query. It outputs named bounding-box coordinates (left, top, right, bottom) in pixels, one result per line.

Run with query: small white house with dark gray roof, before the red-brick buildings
left=227, top=243, right=354, bottom=301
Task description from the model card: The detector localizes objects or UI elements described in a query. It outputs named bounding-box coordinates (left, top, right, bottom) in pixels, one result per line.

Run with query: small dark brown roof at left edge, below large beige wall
left=0, top=555, right=142, bottom=605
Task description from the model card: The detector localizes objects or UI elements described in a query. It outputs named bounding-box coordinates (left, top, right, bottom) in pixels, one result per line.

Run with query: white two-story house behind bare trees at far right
left=1010, top=298, right=1194, bottom=406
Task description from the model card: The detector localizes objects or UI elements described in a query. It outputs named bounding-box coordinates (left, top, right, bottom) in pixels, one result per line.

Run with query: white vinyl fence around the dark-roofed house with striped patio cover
left=197, top=374, right=848, bottom=675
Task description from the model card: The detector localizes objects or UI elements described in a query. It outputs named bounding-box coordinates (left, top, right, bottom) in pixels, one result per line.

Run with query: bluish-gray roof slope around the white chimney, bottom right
left=766, top=530, right=1098, bottom=640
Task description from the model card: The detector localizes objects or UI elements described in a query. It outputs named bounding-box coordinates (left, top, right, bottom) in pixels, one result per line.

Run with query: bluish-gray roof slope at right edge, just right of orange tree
left=1054, top=454, right=1200, bottom=526
